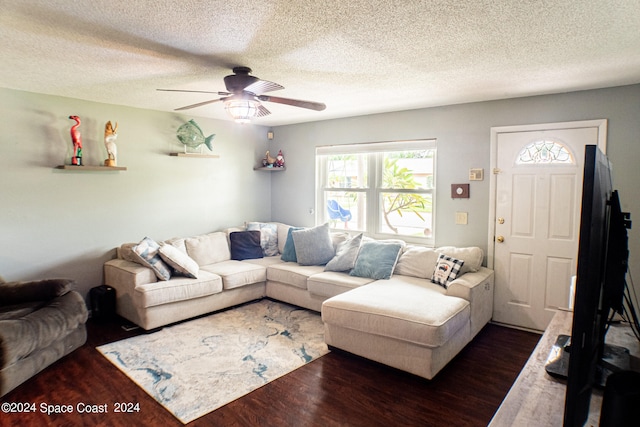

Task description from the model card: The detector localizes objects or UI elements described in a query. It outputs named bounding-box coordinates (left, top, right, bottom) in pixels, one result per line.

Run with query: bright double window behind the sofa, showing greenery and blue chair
left=316, top=140, right=436, bottom=244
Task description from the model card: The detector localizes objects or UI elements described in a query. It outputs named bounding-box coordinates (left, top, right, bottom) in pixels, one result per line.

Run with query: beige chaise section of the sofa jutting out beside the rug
left=322, top=276, right=472, bottom=379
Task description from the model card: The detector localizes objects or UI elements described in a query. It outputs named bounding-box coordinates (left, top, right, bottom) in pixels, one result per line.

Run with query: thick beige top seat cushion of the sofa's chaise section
left=322, top=276, right=470, bottom=347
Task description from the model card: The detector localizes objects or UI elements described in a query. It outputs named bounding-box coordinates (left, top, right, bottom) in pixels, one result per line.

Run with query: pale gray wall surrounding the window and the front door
left=270, top=85, right=640, bottom=292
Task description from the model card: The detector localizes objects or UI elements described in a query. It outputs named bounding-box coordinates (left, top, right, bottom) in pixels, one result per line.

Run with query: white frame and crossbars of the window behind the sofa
left=316, top=139, right=437, bottom=246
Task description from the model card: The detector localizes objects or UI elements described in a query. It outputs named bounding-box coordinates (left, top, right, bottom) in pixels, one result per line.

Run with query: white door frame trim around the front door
left=487, top=119, right=607, bottom=269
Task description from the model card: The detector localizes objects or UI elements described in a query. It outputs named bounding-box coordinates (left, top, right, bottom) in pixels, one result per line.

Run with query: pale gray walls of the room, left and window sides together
left=0, top=85, right=640, bottom=308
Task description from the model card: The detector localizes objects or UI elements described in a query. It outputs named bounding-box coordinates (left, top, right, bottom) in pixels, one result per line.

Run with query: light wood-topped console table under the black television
left=489, top=311, right=640, bottom=427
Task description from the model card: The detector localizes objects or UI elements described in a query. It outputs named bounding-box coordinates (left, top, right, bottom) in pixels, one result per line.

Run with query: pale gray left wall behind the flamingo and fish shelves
left=0, top=89, right=271, bottom=300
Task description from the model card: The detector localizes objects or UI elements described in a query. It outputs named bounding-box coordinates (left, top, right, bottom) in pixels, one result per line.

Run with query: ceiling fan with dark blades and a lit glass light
left=158, top=67, right=326, bottom=123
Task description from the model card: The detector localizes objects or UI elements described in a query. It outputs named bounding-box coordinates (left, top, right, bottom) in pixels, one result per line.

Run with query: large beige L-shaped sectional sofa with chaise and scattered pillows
left=104, top=223, right=493, bottom=379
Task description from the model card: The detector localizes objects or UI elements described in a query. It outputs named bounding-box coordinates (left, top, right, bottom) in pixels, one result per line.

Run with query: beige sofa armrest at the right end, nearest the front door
left=447, top=267, right=493, bottom=337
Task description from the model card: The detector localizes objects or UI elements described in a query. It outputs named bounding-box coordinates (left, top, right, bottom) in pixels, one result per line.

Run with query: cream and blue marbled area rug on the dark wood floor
left=98, top=300, right=329, bottom=424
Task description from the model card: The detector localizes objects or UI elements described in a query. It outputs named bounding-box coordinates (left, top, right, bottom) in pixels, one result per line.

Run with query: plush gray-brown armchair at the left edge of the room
left=0, top=279, right=88, bottom=396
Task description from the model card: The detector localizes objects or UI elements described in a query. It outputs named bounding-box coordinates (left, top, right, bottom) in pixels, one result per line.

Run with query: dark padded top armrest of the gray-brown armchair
left=0, top=279, right=74, bottom=305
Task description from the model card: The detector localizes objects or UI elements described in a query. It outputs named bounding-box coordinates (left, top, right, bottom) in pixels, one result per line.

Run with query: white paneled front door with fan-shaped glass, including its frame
left=489, top=120, right=606, bottom=331
